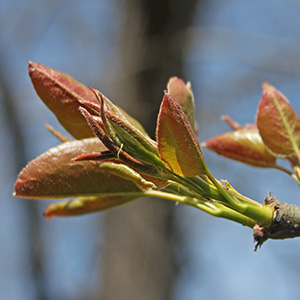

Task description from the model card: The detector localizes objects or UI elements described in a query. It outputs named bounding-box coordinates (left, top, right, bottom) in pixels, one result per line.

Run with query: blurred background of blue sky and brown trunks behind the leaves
left=0, top=0, right=300, bottom=300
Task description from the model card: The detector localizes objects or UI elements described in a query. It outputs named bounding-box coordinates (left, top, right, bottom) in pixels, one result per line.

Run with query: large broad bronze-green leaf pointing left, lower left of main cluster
left=15, top=138, right=141, bottom=199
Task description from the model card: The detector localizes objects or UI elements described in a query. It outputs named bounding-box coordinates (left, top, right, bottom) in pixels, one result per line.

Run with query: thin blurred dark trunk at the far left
left=0, top=56, right=48, bottom=300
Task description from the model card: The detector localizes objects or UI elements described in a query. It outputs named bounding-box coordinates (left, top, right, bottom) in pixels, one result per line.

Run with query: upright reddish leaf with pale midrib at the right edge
left=256, top=84, right=300, bottom=156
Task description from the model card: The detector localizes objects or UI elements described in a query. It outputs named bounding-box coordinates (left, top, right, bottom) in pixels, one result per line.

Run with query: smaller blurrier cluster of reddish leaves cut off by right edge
left=202, top=82, right=300, bottom=184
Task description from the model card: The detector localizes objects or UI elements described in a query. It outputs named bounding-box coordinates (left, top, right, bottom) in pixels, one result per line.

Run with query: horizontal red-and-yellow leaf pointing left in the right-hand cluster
left=203, top=129, right=276, bottom=168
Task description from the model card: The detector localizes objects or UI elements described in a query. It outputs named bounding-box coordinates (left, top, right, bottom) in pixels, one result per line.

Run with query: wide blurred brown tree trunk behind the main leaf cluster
left=101, top=0, right=197, bottom=300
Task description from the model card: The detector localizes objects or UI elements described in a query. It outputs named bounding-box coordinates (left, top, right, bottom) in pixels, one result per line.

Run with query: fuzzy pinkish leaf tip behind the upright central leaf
left=167, top=77, right=197, bottom=132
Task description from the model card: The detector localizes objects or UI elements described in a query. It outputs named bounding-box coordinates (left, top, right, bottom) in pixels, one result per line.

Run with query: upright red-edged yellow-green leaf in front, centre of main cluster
left=156, top=94, right=206, bottom=176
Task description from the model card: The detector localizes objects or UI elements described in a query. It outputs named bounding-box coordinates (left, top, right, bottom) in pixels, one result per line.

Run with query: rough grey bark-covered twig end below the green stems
left=253, top=194, right=300, bottom=250
